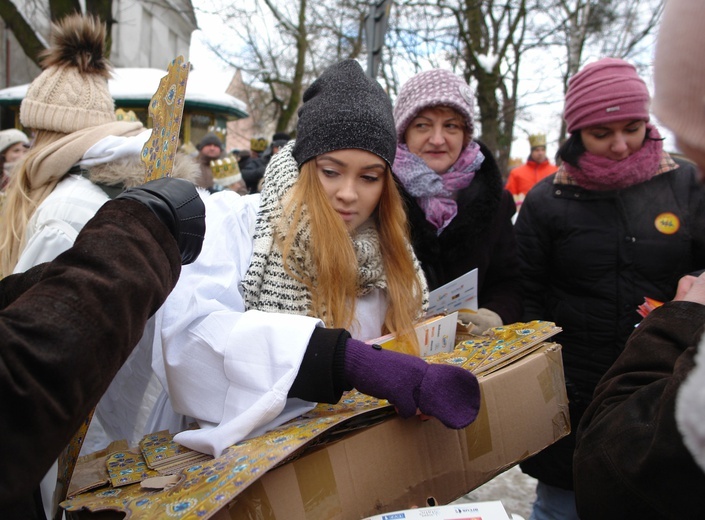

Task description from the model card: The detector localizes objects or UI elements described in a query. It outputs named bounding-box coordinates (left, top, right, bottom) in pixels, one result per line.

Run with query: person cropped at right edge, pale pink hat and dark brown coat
left=573, top=0, right=705, bottom=520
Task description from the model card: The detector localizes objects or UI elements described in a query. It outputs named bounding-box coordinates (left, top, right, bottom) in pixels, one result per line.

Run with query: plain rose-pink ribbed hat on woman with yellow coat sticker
left=563, top=58, right=650, bottom=133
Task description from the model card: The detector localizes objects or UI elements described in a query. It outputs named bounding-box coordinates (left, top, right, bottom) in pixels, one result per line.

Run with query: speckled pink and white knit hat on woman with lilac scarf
left=394, top=69, right=473, bottom=143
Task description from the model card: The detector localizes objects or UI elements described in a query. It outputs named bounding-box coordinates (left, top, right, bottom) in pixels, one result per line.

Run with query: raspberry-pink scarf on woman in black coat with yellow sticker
left=564, top=125, right=663, bottom=191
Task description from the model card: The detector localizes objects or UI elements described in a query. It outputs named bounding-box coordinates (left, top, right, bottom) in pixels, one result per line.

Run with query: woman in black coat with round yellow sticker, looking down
left=516, top=54, right=705, bottom=519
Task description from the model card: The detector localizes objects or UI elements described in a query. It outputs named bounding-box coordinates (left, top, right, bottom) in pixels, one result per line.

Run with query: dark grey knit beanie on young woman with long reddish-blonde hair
left=292, top=60, right=397, bottom=167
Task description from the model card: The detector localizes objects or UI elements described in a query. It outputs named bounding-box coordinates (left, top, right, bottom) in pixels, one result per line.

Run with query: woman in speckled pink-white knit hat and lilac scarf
left=394, top=69, right=522, bottom=332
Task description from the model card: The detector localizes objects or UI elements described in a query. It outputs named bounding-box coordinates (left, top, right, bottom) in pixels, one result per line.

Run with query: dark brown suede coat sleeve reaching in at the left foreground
left=0, top=200, right=181, bottom=518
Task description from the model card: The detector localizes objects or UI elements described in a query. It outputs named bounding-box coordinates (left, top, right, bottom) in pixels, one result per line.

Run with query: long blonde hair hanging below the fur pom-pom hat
left=0, top=130, right=66, bottom=276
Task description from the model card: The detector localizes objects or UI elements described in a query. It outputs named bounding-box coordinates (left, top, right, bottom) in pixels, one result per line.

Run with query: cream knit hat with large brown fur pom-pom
left=20, top=14, right=116, bottom=134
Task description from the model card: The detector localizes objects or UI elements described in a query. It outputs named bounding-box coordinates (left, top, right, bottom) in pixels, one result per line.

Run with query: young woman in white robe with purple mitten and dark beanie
left=152, top=60, right=479, bottom=456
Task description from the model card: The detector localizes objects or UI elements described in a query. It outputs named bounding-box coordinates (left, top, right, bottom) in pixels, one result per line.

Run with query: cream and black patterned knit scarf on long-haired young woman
left=242, top=141, right=426, bottom=321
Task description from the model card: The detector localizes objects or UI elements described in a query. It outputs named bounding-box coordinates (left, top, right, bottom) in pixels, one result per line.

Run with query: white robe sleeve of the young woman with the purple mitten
left=152, top=192, right=322, bottom=456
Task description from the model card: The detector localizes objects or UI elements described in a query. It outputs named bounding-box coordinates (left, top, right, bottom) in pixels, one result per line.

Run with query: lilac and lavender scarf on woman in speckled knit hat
left=394, top=141, right=485, bottom=235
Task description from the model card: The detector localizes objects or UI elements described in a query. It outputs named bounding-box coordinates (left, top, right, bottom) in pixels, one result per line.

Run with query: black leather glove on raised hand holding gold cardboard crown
left=115, top=177, right=206, bottom=265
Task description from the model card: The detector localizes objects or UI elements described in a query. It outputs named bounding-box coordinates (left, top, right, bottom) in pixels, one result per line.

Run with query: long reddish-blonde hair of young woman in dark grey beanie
left=275, top=160, right=423, bottom=348
